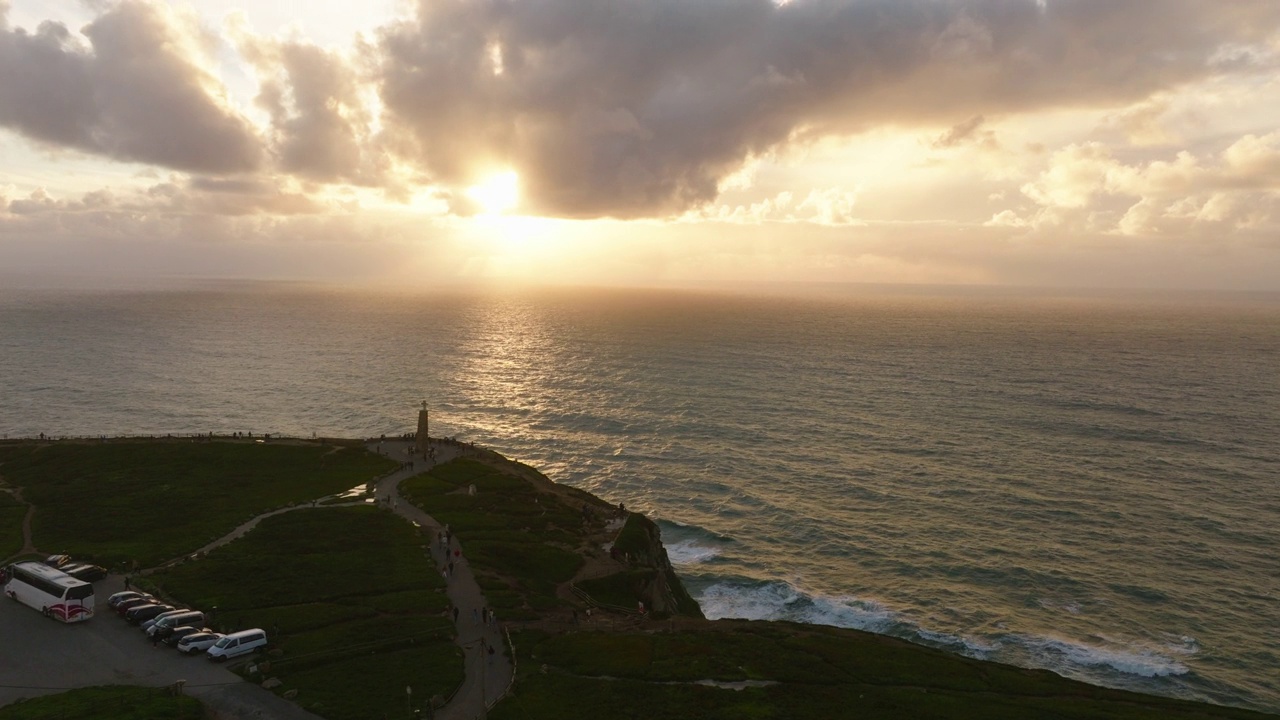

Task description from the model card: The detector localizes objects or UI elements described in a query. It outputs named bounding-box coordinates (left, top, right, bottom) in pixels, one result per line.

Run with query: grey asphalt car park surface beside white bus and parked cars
left=0, top=575, right=317, bottom=720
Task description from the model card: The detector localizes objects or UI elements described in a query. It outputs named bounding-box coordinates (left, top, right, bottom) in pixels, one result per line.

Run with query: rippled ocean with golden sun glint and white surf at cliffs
left=0, top=283, right=1280, bottom=712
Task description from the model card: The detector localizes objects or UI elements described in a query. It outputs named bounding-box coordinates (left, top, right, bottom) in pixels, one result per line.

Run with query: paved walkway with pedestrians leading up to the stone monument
left=369, top=441, right=513, bottom=720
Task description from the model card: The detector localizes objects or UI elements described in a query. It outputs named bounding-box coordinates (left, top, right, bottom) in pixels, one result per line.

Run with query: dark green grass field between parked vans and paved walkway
left=145, top=506, right=462, bottom=720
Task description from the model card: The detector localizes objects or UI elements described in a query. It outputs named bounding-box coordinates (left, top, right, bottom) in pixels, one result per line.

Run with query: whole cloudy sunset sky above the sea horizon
left=0, top=0, right=1280, bottom=291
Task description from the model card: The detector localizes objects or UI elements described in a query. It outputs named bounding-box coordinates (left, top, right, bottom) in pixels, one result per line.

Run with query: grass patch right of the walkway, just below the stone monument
left=401, top=460, right=582, bottom=620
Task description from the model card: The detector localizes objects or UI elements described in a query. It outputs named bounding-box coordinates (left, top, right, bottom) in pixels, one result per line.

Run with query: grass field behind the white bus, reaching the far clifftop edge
left=0, top=441, right=396, bottom=568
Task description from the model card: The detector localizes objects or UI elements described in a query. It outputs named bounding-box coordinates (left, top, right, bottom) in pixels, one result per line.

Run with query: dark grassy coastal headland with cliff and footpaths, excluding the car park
left=0, top=437, right=1266, bottom=720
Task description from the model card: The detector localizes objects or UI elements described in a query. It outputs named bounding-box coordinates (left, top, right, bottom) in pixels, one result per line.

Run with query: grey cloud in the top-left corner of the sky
left=0, top=0, right=262, bottom=173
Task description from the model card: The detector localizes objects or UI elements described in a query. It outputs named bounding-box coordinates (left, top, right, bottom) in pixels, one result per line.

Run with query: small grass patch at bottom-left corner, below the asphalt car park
left=0, top=685, right=205, bottom=720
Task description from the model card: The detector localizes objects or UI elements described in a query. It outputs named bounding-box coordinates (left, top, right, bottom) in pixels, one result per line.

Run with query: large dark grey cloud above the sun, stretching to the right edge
left=381, top=0, right=1280, bottom=217
